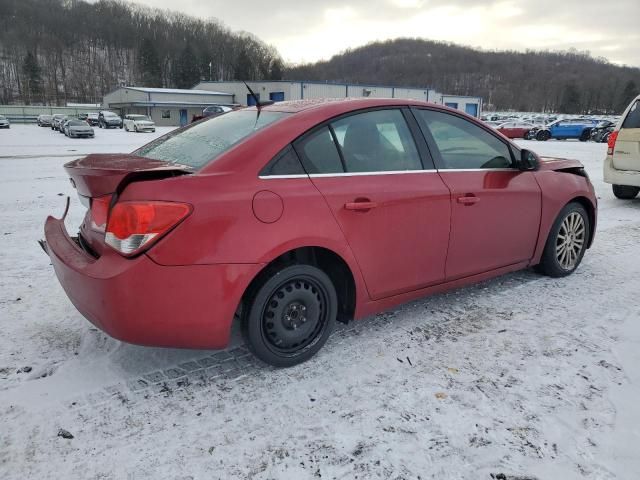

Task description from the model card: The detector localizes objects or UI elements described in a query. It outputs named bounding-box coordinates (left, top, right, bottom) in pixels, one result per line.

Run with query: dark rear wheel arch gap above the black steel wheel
left=238, top=245, right=357, bottom=323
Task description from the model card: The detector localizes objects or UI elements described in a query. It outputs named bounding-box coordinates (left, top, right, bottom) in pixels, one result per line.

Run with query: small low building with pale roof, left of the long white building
left=102, top=87, right=233, bottom=126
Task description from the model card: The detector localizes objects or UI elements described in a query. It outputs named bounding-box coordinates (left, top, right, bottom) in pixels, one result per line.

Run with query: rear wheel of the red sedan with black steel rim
left=242, top=265, right=338, bottom=367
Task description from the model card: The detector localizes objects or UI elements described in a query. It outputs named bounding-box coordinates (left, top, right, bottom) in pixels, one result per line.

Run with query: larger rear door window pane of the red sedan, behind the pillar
left=331, top=109, right=422, bottom=172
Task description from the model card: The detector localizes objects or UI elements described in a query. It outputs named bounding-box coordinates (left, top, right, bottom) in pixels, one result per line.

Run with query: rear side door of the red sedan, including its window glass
left=294, top=108, right=451, bottom=300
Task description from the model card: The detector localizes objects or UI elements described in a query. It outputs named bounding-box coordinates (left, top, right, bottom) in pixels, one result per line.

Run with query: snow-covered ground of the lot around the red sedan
left=0, top=125, right=640, bottom=480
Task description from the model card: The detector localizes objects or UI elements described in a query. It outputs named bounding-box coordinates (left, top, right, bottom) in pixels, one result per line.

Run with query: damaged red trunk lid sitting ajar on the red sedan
left=64, top=153, right=192, bottom=198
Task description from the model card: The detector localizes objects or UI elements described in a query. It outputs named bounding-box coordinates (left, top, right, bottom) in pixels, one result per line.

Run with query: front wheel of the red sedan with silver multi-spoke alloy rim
left=536, top=202, right=591, bottom=278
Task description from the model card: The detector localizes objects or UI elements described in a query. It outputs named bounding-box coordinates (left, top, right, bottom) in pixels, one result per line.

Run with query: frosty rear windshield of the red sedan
left=133, top=110, right=290, bottom=168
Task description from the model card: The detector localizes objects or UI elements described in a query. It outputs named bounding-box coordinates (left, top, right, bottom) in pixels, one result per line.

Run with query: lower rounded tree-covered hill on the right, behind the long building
left=286, top=38, right=640, bottom=113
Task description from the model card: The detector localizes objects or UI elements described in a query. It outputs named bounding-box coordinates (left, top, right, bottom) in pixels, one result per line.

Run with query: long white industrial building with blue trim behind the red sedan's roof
left=194, top=80, right=482, bottom=117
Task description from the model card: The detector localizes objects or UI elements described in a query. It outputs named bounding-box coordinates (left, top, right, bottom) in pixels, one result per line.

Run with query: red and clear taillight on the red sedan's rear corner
left=105, top=202, right=191, bottom=256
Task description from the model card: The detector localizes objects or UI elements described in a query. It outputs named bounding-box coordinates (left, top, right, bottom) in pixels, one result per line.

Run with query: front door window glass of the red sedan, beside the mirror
left=416, top=110, right=513, bottom=170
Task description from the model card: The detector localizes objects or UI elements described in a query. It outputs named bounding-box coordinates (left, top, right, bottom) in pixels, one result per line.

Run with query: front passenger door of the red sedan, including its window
left=414, top=109, right=541, bottom=280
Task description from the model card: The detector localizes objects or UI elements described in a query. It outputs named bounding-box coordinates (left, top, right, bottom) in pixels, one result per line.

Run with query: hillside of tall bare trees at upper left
left=0, top=0, right=283, bottom=105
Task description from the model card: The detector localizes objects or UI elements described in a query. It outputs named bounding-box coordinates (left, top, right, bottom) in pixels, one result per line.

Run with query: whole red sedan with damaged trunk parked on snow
left=43, top=99, right=596, bottom=366
